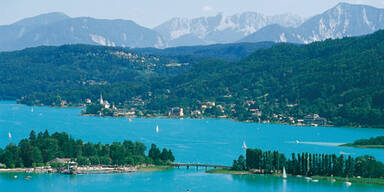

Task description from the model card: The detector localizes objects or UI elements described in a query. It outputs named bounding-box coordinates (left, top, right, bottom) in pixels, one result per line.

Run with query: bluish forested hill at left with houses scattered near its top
left=0, top=45, right=197, bottom=99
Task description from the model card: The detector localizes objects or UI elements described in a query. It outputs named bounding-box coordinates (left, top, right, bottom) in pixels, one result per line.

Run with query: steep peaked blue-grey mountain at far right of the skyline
left=239, top=3, right=384, bottom=44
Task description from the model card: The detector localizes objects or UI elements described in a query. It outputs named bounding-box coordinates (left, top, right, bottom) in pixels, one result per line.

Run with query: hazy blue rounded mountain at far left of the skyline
left=0, top=13, right=164, bottom=51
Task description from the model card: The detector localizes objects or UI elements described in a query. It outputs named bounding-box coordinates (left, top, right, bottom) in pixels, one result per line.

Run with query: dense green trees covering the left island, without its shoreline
left=0, top=131, right=175, bottom=168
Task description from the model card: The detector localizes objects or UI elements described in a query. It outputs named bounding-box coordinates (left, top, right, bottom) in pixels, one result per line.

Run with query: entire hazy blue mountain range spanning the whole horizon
left=0, top=3, right=384, bottom=51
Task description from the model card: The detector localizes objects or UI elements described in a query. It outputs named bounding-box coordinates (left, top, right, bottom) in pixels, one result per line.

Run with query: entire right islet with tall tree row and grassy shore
left=206, top=149, right=384, bottom=185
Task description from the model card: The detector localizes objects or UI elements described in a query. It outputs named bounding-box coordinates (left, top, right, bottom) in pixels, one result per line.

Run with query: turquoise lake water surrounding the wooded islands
left=0, top=101, right=384, bottom=192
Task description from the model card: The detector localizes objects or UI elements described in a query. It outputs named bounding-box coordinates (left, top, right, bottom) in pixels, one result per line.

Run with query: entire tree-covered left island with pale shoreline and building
left=0, top=130, right=175, bottom=174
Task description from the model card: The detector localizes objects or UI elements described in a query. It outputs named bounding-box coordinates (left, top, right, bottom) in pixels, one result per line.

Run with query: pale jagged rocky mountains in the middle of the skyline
left=154, top=12, right=303, bottom=47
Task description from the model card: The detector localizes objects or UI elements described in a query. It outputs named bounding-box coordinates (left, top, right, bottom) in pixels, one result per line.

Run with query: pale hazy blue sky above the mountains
left=0, top=0, right=384, bottom=27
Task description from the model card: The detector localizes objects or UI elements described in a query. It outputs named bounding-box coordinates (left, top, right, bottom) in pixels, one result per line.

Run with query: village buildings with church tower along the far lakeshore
left=83, top=95, right=328, bottom=126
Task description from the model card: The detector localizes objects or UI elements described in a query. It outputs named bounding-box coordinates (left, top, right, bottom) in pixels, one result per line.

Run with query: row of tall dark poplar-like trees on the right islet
left=232, top=149, right=384, bottom=178
